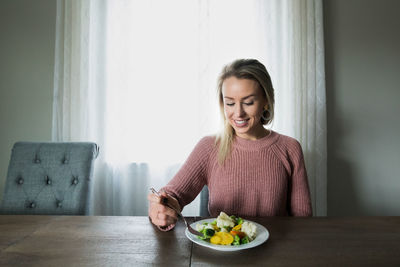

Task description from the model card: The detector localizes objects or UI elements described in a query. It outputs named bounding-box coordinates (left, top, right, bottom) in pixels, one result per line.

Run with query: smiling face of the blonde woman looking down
left=222, top=76, right=267, bottom=140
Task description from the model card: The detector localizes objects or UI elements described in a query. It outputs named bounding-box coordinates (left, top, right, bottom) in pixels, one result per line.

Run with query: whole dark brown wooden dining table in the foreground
left=0, top=215, right=400, bottom=266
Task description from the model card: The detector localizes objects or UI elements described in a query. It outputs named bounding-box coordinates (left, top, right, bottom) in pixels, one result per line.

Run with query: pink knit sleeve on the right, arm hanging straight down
left=288, top=139, right=312, bottom=216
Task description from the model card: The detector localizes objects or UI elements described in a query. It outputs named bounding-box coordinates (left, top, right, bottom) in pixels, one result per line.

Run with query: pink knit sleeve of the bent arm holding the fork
left=162, top=137, right=214, bottom=209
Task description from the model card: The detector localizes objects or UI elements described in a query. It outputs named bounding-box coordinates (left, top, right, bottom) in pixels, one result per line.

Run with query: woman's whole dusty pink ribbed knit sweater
left=163, top=131, right=312, bottom=217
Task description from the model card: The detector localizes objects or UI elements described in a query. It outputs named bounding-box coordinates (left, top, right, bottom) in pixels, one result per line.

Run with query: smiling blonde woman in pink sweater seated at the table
left=148, top=59, right=312, bottom=230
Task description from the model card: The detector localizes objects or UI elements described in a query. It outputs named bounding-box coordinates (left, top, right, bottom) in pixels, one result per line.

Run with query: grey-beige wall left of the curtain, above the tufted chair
left=0, top=0, right=56, bottom=197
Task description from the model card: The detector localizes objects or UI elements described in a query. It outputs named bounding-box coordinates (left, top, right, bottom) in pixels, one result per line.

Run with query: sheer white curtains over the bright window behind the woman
left=53, top=0, right=326, bottom=215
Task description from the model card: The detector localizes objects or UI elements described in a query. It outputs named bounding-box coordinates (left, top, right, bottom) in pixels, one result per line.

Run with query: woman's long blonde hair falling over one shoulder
left=215, top=59, right=275, bottom=165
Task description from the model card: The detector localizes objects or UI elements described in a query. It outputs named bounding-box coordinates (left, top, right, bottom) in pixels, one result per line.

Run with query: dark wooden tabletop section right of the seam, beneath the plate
left=191, top=217, right=400, bottom=266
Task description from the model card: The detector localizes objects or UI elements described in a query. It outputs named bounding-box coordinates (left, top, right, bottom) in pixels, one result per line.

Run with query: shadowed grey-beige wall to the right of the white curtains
left=324, top=0, right=400, bottom=215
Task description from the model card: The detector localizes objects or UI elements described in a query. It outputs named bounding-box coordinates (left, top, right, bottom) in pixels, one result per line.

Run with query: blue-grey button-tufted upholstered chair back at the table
left=0, top=142, right=99, bottom=215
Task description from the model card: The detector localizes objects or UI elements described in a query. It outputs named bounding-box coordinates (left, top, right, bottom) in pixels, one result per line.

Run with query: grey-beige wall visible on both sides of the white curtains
left=0, top=0, right=400, bottom=215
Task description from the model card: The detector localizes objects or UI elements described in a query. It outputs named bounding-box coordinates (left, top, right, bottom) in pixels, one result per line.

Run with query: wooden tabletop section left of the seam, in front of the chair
left=0, top=216, right=192, bottom=266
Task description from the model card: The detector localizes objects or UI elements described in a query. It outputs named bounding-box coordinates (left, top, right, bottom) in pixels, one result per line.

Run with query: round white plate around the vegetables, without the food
left=185, top=218, right=269, bottom=251
